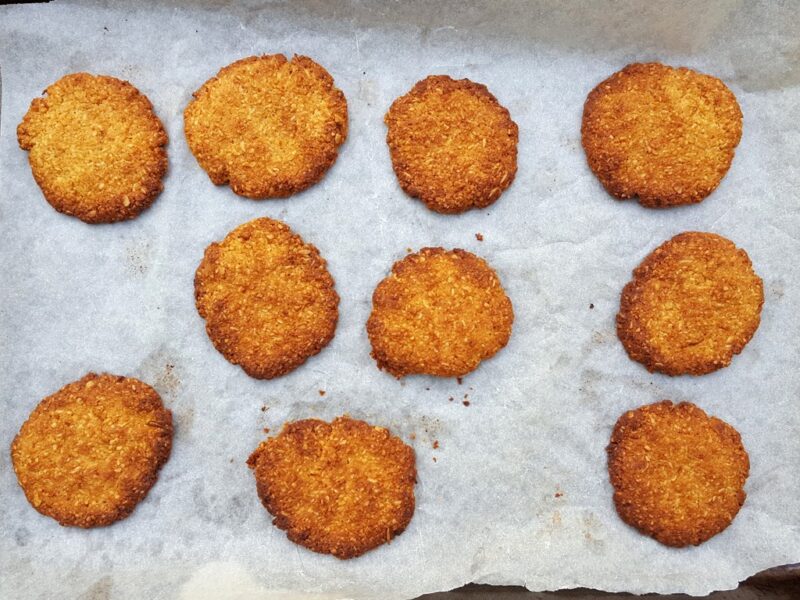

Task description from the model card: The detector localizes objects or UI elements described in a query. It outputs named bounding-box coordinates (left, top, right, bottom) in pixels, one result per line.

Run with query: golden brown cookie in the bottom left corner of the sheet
left=11, top=373, right=172, bottom=527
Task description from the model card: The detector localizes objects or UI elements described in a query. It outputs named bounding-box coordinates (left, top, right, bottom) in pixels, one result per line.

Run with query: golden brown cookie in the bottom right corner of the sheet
left=607, top=400, right=750, bottom=546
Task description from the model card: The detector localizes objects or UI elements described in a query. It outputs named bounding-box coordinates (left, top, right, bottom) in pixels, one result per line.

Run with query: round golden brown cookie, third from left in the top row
left=384, top=75, right=519, bottom=213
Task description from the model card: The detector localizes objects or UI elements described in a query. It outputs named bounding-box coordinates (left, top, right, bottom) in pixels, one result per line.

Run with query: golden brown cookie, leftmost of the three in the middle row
left=194, top=218, right=339, bottom=379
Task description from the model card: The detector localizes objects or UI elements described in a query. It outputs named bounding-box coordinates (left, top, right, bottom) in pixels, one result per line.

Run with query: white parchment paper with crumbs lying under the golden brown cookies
left=0, top=1, right=800, bottom=599
